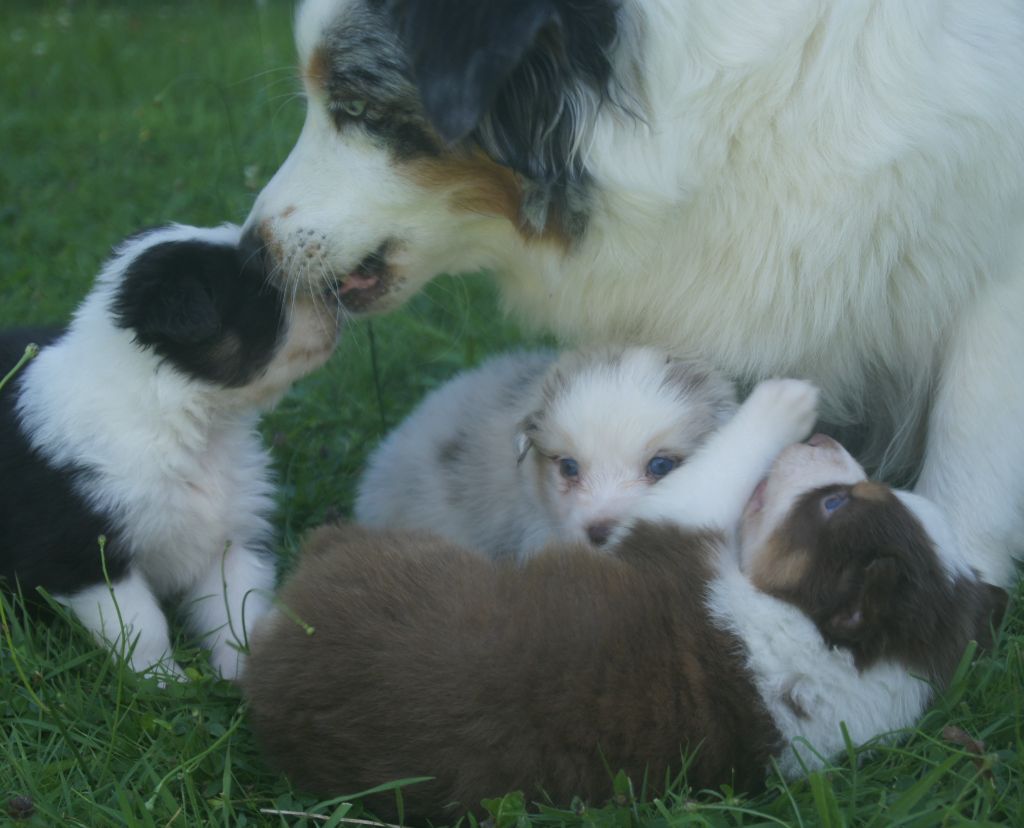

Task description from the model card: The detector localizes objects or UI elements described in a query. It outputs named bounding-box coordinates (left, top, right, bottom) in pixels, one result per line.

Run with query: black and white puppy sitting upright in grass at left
left=0, top=224, right=338, bottom=678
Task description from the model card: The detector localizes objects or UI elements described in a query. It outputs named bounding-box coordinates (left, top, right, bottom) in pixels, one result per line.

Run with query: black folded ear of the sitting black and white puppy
left=112, top=242, right=224, bottom=345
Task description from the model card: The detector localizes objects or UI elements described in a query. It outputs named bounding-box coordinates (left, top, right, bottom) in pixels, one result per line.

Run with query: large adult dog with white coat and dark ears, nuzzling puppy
left=241, top=0, right=1024, bottom=582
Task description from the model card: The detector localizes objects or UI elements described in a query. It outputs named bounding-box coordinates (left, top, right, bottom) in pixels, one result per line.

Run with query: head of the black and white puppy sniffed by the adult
left=101, top=224, right=338, bottom=401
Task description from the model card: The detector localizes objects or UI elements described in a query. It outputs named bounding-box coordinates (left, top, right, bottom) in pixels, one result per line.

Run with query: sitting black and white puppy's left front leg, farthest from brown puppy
left=55, top=571, right=184, bottom=679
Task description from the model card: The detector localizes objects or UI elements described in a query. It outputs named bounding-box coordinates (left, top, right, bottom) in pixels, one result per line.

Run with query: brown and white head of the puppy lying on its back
left=740, top=435, right=1007, bottom=685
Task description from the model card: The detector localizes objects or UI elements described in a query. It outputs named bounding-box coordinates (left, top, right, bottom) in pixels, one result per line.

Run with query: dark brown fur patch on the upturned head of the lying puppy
left=752, top=483, right=1007, bottom=687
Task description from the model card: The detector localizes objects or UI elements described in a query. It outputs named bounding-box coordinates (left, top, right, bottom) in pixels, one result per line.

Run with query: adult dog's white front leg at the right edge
left=915, top=268, right=1024, bottom=585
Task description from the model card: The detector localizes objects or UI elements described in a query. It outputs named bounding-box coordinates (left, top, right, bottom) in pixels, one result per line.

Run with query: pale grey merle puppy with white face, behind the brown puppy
left=355, top=347, right=736, bottom=561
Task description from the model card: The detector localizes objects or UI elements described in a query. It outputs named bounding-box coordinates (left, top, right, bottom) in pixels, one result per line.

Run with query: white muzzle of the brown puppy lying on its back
left=739, top=435, right=867, bottom=569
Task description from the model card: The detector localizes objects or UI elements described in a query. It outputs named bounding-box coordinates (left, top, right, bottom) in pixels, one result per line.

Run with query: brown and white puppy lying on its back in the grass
left=244, top=381, right=1005, bottom=821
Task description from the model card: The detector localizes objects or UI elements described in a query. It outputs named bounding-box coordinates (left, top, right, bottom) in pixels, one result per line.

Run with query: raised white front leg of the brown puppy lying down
left=631, top=380, right=818, bottom=531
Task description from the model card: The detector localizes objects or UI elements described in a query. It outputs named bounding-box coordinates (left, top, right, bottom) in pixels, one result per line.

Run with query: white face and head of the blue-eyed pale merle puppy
left=516, top=348, right=736, bottom=547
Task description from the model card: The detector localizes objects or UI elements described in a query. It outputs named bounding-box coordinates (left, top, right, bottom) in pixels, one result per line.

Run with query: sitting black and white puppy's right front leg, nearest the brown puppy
left=185, top=546, right=274, bottom=681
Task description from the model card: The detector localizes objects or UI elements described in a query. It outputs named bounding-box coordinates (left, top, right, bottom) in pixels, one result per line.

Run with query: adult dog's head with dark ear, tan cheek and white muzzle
left=247, top=0, right=621, bottom=311
